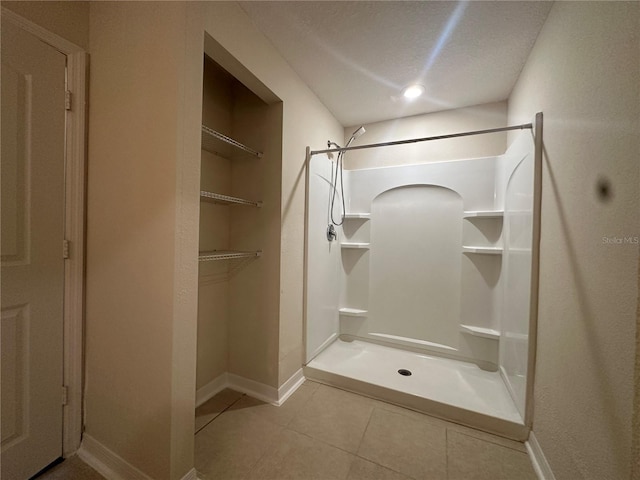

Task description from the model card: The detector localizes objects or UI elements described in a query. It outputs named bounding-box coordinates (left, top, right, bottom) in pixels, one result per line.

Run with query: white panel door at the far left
left=0, top=18, right=66, bottom=480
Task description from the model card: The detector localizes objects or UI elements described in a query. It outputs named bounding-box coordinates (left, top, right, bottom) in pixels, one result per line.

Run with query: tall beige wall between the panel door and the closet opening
left=85, top=2, right=197, bottom=480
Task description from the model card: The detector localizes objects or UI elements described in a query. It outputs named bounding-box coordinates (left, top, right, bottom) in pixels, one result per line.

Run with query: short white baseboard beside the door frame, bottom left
left=78, top=433, right=152, bottom=480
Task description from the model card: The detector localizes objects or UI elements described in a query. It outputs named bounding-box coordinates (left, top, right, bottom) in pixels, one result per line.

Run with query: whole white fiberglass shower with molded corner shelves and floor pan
left=305, top=114, right=542, bottom=440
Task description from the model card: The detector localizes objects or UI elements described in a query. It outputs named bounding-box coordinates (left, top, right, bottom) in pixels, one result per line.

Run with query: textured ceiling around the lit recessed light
left=240, top=1, right=552, bottom=126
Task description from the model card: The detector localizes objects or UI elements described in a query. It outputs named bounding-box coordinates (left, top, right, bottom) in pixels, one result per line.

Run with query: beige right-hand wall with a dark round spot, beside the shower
left=509, top=2, right=640, bottom=480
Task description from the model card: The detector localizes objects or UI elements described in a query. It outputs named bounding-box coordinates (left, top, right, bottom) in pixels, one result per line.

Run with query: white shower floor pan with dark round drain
left=304, top=339, right=528, bottom=441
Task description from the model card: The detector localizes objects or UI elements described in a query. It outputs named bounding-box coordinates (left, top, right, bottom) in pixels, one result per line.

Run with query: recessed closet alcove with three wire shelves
left=196, top=55, right=282, bottom=418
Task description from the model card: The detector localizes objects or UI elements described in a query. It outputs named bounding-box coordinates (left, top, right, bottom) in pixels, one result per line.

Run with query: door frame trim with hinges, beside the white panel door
left=1, top=7, right=88, bottom=457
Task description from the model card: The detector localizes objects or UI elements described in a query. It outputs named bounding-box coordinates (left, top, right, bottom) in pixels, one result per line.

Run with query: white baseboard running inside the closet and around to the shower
left=196, top=369, right=305, bottom=407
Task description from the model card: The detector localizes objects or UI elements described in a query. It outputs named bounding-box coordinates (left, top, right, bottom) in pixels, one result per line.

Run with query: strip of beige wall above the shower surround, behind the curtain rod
left=342, top=101, right=507, bottom=169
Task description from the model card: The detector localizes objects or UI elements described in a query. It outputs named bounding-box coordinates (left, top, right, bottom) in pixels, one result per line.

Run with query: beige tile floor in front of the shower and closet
left=195, top=381, right=536, bottom=480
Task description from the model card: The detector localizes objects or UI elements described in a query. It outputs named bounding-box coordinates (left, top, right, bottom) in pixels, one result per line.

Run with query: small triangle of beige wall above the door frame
left=0, top=1, right=89, bottom=51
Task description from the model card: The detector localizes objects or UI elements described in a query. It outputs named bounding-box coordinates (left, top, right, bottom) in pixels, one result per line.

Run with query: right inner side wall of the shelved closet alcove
left=229, top=83, right=282, bottom=386
